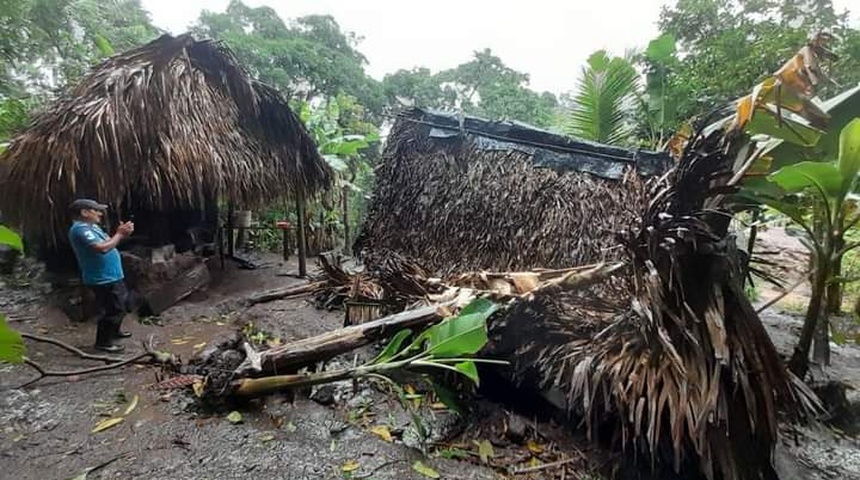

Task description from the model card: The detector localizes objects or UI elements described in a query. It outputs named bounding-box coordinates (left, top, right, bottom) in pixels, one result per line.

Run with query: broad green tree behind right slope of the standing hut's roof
left=197, top=0, right=384, bottom=114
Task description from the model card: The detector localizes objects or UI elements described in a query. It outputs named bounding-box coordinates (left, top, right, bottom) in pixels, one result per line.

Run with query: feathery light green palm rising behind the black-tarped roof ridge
left=564, top=50, right=639, bottom=145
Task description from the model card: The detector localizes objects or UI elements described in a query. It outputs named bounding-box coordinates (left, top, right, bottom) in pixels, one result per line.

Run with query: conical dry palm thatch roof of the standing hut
left=0, top=35, right=332, bottom=244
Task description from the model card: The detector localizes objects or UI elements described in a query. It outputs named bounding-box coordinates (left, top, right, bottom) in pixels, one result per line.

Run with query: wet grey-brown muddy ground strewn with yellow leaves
left=0, top=237, right=860, bottom=480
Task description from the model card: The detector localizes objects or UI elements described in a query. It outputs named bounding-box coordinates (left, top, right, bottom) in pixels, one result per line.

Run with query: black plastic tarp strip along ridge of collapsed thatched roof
left=400, top=108, right=671, bottom=180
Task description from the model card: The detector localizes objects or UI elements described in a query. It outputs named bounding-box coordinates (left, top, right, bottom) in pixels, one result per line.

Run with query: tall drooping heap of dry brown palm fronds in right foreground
left=490, top=124, right=816, bottom=480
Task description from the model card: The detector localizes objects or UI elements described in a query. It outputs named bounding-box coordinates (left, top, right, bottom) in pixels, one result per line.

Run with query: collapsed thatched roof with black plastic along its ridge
left=354, top=109, right=669, bottom=274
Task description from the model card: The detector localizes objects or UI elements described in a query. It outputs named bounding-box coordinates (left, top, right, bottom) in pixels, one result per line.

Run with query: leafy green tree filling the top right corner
left=660, top=0, right=860, bottom=125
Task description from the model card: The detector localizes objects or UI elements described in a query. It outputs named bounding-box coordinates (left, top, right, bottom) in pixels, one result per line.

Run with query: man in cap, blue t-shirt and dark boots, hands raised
left=69, top=199, right=134, bottom=353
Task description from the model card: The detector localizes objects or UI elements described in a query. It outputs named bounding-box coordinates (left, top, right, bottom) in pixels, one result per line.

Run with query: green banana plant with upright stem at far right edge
left=746, top=118, right=860, bottom=375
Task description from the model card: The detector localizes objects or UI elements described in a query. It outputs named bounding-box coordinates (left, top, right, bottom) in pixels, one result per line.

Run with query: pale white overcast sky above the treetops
left=142, top=0, right=860, bottom=94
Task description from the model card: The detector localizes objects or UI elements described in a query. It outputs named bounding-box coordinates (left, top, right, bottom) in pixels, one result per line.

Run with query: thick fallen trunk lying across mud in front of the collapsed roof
left=235, top=302, right=454, bottom=377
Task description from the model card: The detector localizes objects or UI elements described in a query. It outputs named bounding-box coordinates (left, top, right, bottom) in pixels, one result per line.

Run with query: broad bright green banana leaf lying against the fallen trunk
left=427, top=299, right=499, bottom=358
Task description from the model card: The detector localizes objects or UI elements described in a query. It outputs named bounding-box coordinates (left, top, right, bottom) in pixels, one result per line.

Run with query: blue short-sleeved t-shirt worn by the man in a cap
left=69, top=221, right=124, bottom=285
